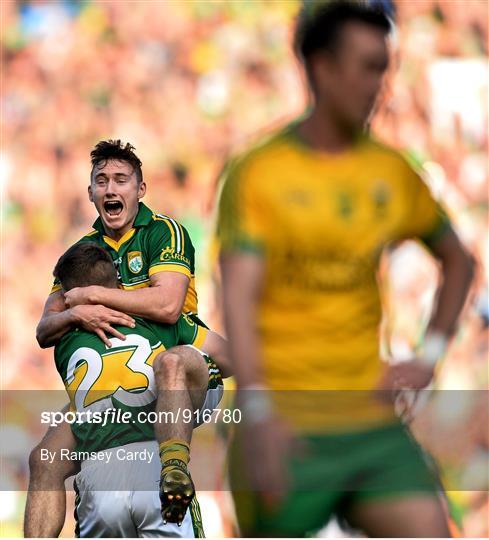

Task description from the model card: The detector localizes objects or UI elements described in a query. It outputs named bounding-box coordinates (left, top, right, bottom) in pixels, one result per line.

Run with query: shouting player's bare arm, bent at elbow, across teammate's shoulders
left=65, top=272, right=190, bottom=324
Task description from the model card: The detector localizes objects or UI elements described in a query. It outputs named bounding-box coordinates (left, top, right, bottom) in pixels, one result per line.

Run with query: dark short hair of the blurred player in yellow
left=294, top=0, right=391, bottom=63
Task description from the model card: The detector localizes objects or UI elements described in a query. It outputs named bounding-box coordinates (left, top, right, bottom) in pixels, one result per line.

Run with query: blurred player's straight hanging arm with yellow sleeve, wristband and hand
left=217, top=157, right=292, bottom=497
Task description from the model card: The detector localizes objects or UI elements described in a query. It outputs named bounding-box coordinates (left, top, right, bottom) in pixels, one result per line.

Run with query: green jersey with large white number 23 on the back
left=54, top=315, right=207, bottom=452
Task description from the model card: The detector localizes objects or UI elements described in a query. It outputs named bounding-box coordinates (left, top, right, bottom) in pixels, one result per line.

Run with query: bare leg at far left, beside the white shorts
left=24, top=418, right=77, bottom=538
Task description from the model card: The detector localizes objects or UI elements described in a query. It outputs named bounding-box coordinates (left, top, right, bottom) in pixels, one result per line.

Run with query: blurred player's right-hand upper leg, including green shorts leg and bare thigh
left=344, top=424, right=450, bottom=538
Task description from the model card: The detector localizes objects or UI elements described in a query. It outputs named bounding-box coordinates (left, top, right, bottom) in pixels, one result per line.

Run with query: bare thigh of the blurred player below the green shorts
left=348, top=493, right=451, bottom=538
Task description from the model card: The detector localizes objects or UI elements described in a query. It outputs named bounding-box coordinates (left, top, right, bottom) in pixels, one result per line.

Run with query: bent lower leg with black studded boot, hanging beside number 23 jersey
left=153, top=346, right=209, bottom=523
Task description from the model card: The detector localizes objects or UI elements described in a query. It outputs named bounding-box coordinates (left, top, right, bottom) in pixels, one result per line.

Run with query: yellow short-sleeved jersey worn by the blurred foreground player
left=217, top=123, right=448, bottom=430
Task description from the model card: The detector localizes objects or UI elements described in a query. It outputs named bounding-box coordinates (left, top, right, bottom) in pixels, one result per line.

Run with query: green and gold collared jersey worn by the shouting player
left=51, top=203, right=197, bottom=313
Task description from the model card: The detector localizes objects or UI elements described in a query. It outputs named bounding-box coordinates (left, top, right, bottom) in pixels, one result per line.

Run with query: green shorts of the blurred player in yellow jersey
left=231, top=424, right=440, bottom=537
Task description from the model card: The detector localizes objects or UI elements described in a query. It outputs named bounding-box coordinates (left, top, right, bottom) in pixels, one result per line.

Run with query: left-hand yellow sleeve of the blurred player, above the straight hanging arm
left=216, top=160, right=267, bottom=253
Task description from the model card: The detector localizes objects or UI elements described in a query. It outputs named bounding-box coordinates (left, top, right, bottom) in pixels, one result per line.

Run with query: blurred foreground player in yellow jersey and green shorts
left=218, top=2, right=473, bottom=537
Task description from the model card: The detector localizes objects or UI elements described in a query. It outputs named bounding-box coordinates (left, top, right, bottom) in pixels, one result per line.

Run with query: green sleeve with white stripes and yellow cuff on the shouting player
left=148, top=215, right=195, bottom=279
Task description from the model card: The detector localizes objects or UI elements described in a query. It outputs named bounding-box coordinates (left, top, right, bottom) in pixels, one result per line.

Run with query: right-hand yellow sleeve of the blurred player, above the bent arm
left=402, top=158, right=450, bottom=247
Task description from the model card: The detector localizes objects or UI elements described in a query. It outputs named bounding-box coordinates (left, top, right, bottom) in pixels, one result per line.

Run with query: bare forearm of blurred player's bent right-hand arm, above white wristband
left=429, top=252, right=474, bottom=336
